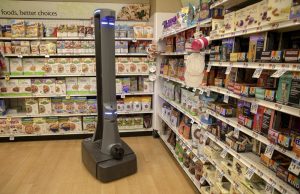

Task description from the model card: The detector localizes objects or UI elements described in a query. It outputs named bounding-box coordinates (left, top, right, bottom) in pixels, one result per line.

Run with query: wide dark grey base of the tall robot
left=81, top=138, right=137, bottom=182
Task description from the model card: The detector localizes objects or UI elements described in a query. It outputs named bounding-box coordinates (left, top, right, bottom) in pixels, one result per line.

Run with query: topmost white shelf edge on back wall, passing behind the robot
left=0, top=37, right=153, bottom=41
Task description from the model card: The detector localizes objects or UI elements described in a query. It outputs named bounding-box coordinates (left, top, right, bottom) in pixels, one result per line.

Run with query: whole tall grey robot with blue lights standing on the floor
left=81, top=9, right=137, bottom=182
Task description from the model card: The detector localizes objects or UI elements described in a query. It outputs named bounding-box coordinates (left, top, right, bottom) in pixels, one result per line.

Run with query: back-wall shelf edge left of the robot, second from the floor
left=0, top=113, right=97, bottom=119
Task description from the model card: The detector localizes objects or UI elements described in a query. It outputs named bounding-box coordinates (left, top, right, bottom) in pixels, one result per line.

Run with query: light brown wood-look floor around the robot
left=0, top=137, right=196, bottom=194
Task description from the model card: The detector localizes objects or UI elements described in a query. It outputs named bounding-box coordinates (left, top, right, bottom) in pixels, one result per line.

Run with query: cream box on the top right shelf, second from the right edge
left=268, top=0, right=292, bottom=23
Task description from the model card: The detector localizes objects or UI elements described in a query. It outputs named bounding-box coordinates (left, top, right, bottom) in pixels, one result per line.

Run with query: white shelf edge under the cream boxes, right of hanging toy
left=210, top=18, right=300, bottom=40
